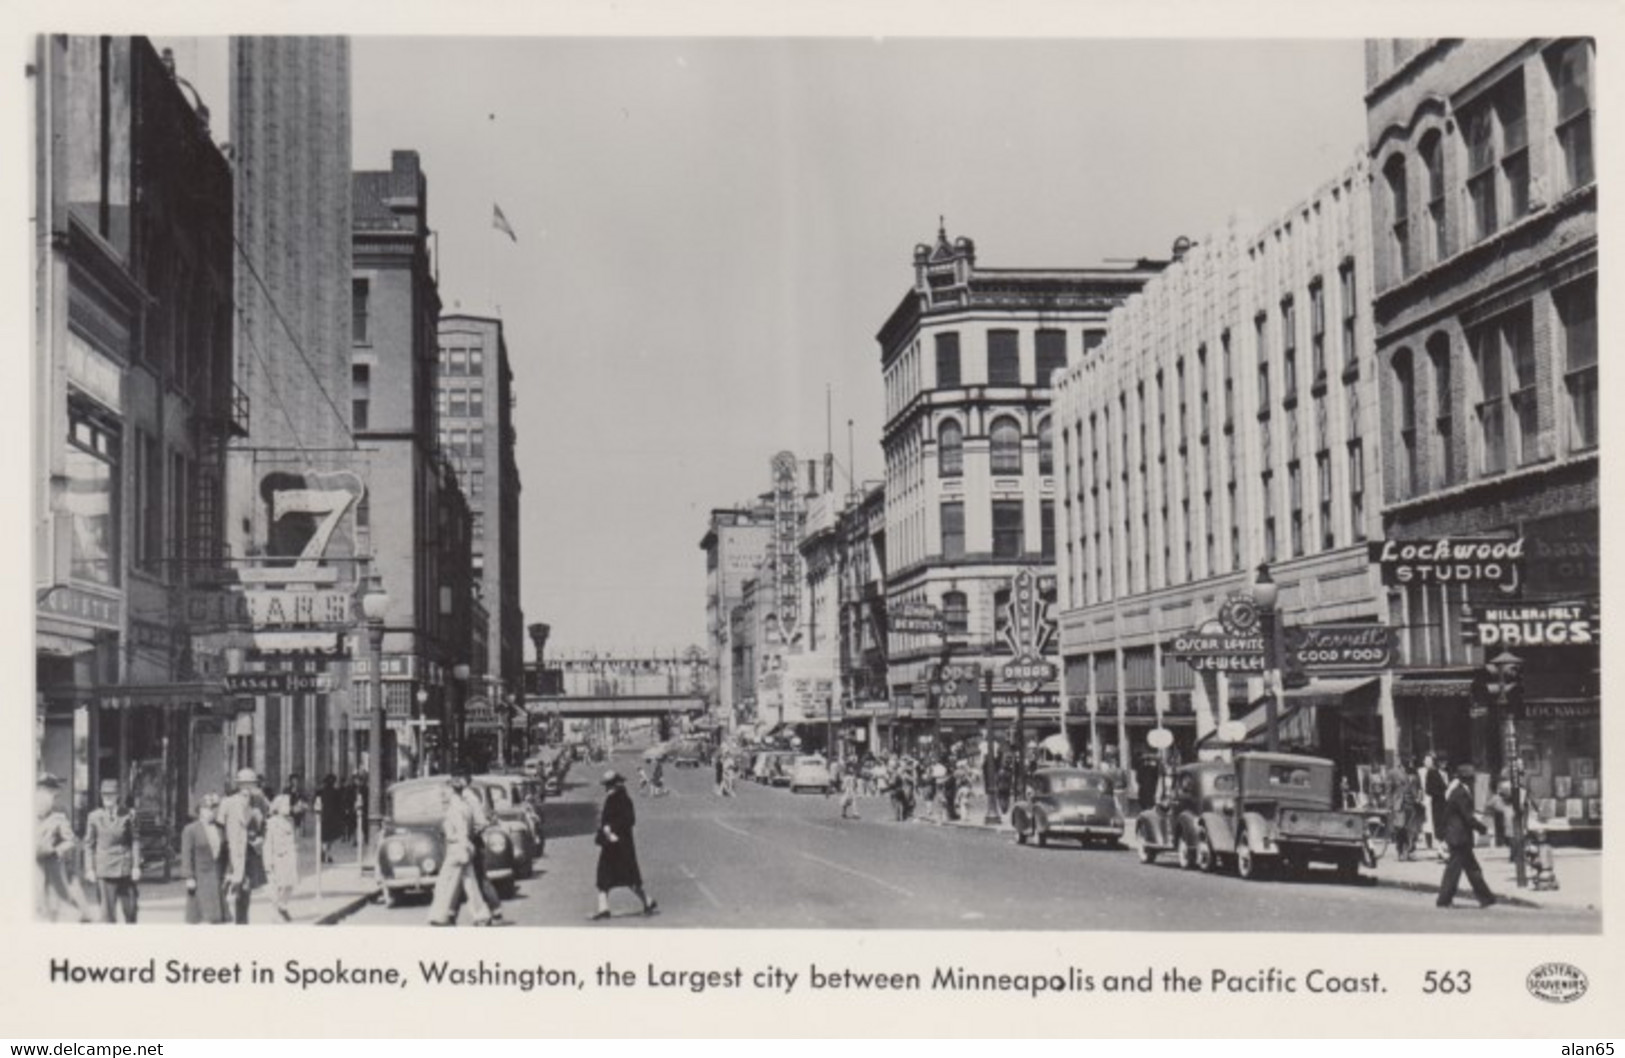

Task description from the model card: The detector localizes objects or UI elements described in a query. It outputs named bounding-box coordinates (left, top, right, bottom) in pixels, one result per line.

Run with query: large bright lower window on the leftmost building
left=62, top=400, right=122, bottom=585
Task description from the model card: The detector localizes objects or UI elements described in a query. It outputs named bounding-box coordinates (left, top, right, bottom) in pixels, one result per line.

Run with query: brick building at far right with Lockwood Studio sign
left=1367, top=39, right=1601, bottom=832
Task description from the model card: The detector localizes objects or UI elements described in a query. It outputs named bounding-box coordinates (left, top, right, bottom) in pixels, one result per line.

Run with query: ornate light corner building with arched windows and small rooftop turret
left=878, top=229, right=1164, bottom=754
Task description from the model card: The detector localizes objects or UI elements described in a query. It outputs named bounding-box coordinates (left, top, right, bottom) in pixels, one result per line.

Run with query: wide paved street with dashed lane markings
left=345, top=754, right=1601, bottom=933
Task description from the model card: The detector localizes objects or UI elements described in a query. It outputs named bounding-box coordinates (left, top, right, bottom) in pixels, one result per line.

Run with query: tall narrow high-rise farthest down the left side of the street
left=436, top=314, right=525, bottom=756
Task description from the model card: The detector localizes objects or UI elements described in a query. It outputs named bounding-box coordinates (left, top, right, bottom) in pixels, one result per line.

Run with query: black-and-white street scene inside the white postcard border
left=25, top=29, right=1610, bottom=949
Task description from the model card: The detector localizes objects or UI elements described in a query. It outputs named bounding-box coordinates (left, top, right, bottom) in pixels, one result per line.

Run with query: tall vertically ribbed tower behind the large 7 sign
left=226, top=37, right=366, bottom=788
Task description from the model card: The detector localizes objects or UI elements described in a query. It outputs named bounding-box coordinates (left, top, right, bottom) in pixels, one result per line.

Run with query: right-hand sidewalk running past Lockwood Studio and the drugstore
left=916, top=795, right=1602, bottom=912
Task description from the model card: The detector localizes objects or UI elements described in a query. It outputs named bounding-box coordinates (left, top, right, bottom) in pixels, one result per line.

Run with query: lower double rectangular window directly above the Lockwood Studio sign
left=1467, top=304, right=1539, bottom=475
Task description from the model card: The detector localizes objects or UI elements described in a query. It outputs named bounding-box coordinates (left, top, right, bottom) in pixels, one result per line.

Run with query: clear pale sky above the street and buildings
left=155, top=37, right=1365, bottom=652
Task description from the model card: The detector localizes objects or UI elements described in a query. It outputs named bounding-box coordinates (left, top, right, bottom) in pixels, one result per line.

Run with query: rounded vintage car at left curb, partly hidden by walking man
left=377, top=775, right=514, bottom=907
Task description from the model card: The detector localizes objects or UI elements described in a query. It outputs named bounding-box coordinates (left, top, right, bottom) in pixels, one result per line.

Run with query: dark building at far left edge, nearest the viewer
left=31, top=36, right=242, bottom=838
